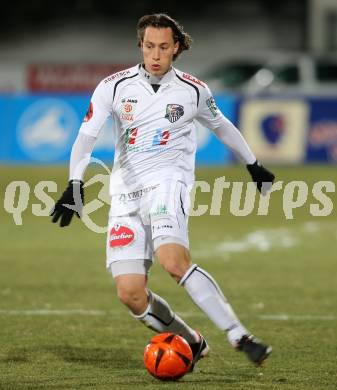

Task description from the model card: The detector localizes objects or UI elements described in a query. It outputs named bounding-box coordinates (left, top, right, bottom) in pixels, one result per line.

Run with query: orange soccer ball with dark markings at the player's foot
left=144, top=333, right=193, bottom=380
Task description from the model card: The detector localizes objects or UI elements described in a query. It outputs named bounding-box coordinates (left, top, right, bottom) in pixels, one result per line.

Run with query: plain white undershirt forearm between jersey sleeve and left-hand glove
left=69, top=133, right=96, bottom=181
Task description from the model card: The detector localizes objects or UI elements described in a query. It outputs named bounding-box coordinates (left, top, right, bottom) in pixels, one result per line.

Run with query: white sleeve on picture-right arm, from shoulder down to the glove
left=196, top=86, right=256, bottom=164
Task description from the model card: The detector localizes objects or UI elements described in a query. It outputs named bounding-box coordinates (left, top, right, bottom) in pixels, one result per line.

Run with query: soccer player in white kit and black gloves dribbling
left=52, top=14, right=274, bottom=366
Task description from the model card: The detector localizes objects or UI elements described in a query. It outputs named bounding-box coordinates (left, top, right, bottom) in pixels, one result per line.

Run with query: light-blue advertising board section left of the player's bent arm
left=0, top=95, right=88, bottom=164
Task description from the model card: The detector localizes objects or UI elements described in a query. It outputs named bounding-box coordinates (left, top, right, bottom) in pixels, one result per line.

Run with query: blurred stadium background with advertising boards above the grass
left=0, top=0, right=337, bottom=165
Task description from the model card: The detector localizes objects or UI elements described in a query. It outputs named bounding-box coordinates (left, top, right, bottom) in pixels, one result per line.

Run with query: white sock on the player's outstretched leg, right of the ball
left=179, top=264, right=249, bottom=346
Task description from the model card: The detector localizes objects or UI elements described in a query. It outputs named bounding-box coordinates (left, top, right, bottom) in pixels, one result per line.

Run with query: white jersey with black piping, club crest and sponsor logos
left=80, top=65, right=255, bottom=195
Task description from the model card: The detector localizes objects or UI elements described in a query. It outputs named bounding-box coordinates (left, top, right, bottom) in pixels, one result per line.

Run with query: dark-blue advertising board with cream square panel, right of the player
left=239, top=96, right=337, bottom=164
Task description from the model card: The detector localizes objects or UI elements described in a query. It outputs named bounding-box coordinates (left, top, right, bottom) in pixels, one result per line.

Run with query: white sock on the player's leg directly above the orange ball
left=130, top=291, right=199, bottom=344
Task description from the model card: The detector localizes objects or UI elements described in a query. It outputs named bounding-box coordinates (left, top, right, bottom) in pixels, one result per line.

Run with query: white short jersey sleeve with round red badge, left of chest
left=79, top=80, right=112, bottom=138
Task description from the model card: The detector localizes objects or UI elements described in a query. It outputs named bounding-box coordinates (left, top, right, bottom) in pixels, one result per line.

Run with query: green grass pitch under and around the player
left=0, top=166, right=337, bottom=390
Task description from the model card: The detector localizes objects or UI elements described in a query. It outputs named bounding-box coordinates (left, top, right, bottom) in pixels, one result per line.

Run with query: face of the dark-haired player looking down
left=141, top=27, right=179, bottom=76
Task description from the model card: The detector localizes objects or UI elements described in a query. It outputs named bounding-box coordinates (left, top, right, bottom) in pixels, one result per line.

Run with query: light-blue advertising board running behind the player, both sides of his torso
left=0, top=94, right=236, bottom=165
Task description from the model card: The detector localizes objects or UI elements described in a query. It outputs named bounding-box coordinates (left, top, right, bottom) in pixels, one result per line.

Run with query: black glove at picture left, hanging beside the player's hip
left=50, top=180, right=84, bottom=227
